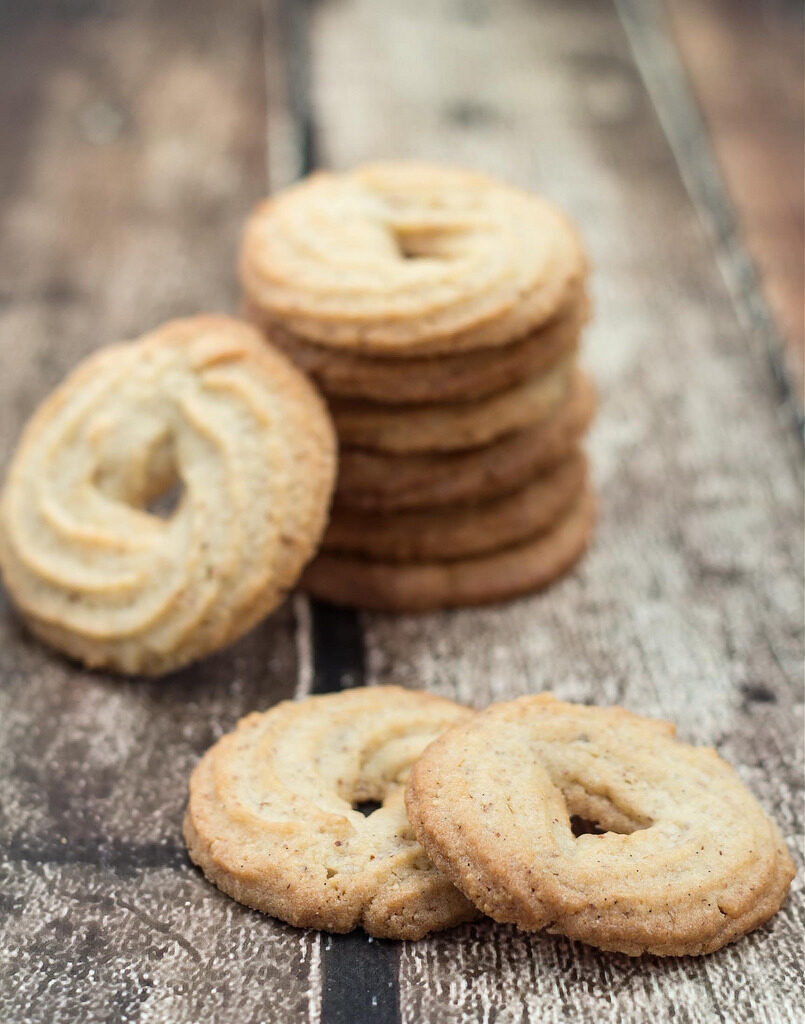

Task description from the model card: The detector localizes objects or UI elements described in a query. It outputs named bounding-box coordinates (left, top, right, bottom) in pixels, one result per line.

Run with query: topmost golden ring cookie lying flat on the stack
left=240, top=162, right=585, bottom=356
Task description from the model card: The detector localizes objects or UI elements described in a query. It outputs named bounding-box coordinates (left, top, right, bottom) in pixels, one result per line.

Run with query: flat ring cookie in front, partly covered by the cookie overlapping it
left=184, top=686, right=477, bottom=939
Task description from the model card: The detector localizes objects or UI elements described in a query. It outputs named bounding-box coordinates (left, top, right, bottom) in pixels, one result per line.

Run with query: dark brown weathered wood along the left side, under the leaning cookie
left=0, top=0, right=317, bottom=1024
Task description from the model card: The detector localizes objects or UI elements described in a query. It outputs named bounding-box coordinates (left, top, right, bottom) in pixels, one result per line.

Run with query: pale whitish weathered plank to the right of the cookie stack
left=311, top=0, right=802, bottom=1024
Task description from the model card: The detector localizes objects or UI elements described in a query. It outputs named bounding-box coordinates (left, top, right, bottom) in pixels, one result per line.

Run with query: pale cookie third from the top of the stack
left=329, top=356, right=574, bottom=454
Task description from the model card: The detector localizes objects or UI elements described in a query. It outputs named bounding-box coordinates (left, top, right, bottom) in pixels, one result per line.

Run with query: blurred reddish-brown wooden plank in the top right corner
left=667, top=0, right=805, bottom=401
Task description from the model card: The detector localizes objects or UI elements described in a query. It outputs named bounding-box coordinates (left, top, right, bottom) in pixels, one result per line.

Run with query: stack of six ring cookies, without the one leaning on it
left=241, top=163, right=594, bottom=611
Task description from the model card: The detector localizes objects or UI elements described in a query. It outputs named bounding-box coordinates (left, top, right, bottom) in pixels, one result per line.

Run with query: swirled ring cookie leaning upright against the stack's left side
left=0, top=316, right=336, bottom=675
